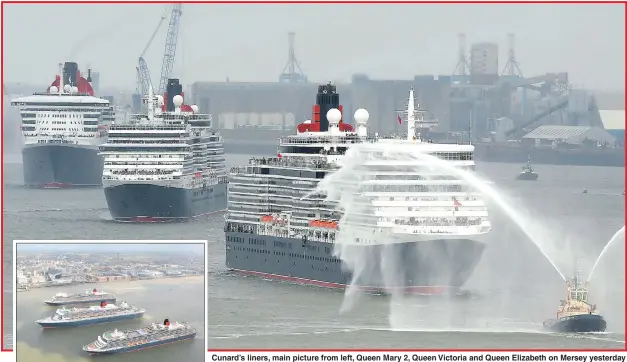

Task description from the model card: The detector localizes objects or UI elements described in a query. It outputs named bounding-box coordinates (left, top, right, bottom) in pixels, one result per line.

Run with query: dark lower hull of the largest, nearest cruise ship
left=226, top=229, right=485, bottom=294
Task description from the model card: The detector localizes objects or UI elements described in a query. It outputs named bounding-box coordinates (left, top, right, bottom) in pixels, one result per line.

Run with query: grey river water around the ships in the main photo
left=4, top=155, right=625, bottom=348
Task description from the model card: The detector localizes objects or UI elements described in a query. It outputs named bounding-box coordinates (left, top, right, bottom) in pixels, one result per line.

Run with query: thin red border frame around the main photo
left=0, top=0, right=627, bottom=353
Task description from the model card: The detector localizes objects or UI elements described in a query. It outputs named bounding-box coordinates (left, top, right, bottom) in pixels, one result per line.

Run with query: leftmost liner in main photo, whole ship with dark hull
left=11, top=62, right=115, bottom=188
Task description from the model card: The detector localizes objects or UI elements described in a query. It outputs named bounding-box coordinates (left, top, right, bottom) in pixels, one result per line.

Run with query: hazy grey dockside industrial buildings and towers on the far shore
left=191, top=33, right=603, bottom=142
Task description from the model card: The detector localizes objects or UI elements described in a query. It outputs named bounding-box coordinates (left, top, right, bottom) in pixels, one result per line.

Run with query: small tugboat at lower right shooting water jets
left=543, top=276, right=607, bottom=333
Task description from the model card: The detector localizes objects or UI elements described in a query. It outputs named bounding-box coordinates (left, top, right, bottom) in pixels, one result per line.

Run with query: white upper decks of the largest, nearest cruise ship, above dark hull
left=227, top=90, right=491, bottom=245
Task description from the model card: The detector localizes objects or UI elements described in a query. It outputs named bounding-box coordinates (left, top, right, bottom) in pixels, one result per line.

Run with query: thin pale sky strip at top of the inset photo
left=16, top=241, right=205, bottom=255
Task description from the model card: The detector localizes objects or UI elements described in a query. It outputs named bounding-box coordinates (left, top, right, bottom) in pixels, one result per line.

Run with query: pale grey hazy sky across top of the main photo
left=3, top=4, right=625, bottom=90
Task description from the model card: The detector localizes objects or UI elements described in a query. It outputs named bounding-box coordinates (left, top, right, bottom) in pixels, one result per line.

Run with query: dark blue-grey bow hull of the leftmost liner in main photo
left=22, top=144, right=104, bottom=188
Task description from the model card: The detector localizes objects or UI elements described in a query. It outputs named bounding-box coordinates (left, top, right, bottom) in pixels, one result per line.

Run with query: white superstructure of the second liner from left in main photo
left=100, top=90, right=226, bottom=189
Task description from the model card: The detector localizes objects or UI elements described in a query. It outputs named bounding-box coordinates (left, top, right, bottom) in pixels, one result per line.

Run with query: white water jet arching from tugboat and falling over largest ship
left=304, top=142, right=566, bottom=311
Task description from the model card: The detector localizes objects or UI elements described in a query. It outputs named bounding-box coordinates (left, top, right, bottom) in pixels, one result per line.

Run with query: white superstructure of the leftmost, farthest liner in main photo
left=11, top=66, right=115, bottom=148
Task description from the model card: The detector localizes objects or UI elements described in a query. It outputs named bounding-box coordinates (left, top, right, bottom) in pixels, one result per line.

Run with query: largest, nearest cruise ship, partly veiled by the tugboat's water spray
left=225, top=84, right=491, bottom=294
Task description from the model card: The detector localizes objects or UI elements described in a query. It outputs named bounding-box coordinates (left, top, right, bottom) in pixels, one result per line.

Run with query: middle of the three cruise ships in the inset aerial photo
left=36, top=301, right=146, bottom=328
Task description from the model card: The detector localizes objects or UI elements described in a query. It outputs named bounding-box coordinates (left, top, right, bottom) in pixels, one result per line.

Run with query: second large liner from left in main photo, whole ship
left=100, top=79, right=227, bottom=222
